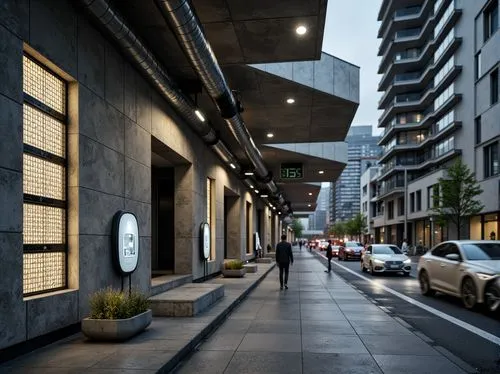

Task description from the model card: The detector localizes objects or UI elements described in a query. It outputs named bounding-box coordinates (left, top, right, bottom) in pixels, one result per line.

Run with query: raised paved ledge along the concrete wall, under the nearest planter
left=0, top=263, right=275, bottom=374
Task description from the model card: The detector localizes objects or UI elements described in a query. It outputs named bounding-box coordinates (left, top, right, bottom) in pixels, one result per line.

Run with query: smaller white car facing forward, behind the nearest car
left=361, top=244, right=411, bottom=276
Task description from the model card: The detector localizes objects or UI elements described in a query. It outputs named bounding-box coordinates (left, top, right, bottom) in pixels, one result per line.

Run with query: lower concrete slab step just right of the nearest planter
left=149, top=283, right=224, bottom=317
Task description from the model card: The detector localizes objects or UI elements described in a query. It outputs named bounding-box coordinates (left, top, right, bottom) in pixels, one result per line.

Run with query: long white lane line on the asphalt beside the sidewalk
left=318, top=253, right=500, bottom=345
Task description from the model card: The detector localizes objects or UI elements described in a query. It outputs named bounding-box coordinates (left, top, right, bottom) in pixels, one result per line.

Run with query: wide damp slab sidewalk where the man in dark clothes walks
left=172, top=249, right=464, bottom=374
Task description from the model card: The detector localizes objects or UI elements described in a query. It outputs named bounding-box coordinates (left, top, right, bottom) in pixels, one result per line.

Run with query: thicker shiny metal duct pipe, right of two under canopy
left=155, top=0, right=278, bottom=194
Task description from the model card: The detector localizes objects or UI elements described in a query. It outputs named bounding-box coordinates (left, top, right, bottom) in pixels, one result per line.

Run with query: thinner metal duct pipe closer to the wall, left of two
left=80, top=0, right=246, bottom=172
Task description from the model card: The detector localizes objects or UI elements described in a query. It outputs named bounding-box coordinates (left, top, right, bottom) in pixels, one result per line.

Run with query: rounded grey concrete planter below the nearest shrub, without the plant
left=82, top=309, right=153, bottom=341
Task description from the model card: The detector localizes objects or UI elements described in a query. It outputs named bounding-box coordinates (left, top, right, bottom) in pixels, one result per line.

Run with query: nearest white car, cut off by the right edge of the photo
left=418, top=240, right=500, bottom=309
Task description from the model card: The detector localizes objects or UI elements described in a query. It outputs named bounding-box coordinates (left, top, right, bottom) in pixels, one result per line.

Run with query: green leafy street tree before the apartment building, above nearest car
left=432, top=158, right=484, bottom=239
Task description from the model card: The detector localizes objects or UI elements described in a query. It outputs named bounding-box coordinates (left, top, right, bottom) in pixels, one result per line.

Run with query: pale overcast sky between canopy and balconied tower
left=323, top=0, right=382, bottom=134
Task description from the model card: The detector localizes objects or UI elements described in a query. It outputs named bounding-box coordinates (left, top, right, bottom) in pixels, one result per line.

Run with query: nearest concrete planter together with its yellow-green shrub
left=82, top=288, right=153, bottom=341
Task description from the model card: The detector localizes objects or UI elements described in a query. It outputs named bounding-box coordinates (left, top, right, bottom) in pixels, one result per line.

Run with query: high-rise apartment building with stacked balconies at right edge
left=374, top=0, right=500, bottom=247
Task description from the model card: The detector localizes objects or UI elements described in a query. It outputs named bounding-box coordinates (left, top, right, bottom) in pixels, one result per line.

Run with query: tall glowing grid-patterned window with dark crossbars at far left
left=23, top=56, right=67, bottom=296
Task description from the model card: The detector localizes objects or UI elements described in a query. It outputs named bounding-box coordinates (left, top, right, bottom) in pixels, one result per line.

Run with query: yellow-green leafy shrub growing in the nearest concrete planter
left=89, top=288, right=149, bottom=319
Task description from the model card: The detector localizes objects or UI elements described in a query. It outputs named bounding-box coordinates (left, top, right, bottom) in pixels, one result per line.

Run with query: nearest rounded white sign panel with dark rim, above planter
left=112, top=211, right=140, bottom=275
